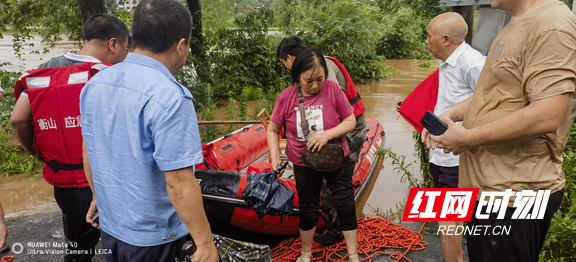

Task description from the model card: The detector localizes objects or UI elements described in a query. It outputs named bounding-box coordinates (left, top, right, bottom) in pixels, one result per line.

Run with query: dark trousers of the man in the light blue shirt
left=102, top=230, right=192, bottom=262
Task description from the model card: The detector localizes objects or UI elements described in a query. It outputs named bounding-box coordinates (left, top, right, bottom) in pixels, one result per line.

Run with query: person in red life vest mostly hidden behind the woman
left=276, top=36, right=366, bottom=246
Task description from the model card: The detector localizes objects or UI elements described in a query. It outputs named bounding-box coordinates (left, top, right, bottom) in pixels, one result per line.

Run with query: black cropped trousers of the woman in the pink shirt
left=294, top=158, right=358, bottom=231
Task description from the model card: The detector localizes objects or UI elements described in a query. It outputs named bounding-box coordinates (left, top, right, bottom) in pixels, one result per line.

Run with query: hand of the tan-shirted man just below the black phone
left=430, top=117, right=470, bottom=155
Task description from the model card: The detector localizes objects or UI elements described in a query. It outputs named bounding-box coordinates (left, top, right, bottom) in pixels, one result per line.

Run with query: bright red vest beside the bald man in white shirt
left=399, top=69, right=440, bottom=133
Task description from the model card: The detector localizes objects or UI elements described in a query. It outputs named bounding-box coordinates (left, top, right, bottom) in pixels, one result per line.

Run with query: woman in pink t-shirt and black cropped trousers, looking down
left=267, top=48, right=359, bottom=262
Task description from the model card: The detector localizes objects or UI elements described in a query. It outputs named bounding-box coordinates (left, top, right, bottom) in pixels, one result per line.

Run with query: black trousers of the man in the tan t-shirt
left=466, top=189, right=564, bottom=262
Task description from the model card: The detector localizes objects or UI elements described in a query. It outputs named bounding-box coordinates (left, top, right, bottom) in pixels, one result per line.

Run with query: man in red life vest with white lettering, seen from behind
left=10, top=14, right=130, bottom=261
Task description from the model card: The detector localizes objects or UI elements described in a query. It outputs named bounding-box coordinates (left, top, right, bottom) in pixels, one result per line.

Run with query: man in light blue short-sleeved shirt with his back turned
left=80, top=0, right=219, bottom=262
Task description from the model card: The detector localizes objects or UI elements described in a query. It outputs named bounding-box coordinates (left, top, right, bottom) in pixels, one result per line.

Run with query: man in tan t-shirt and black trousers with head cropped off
left=423, top=0, right=576, bottom=262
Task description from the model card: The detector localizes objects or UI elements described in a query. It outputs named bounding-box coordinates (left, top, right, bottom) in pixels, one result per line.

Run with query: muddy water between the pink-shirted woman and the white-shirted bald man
left=356, top=60, right=438, bottom=218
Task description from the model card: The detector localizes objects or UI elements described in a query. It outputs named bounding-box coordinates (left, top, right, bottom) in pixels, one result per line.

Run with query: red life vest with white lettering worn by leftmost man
left=14, top=63, right=108, bottom=188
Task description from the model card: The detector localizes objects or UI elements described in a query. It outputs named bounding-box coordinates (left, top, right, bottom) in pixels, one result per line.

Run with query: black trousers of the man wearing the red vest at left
left=54, top=187, right=100, bottom=262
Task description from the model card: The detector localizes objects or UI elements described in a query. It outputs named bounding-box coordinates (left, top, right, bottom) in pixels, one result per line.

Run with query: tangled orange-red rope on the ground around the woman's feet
left=272, top=215, right=428, bottom=262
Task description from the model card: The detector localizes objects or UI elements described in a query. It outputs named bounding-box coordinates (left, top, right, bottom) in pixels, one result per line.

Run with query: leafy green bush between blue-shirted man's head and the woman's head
left=189, top=8, right=289, bottom=99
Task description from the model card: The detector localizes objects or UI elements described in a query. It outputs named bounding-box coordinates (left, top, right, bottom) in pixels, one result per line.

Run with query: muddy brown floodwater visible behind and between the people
left=0, top=35, right=437, bottom=221
